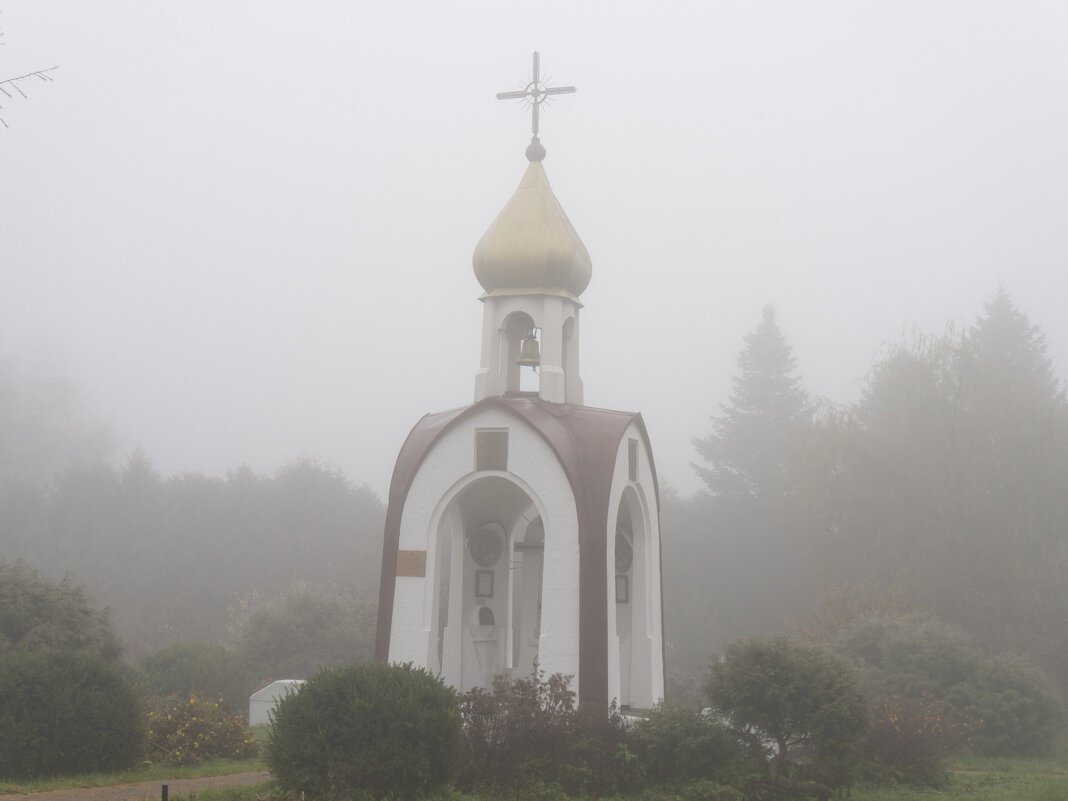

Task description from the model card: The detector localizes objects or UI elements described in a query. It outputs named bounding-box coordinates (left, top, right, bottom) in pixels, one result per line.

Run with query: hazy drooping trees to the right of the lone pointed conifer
left=812, top=293, right=1068, bottom=658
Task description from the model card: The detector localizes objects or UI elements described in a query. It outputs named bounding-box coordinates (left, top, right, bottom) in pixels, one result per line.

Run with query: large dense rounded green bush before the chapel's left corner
left=264, top=663, right=461, bottom=801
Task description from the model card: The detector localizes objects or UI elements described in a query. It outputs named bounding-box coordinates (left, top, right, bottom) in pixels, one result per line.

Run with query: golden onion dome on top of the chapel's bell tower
left=473, top=139, right=593, bottom=297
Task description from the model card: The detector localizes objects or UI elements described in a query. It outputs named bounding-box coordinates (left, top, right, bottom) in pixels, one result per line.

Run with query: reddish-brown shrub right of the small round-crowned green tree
left=865, top=695, right=976, bottom=786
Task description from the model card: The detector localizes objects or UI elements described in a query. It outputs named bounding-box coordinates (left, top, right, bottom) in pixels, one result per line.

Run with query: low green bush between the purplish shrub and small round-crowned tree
left=634, top=703, right=745, bottom=791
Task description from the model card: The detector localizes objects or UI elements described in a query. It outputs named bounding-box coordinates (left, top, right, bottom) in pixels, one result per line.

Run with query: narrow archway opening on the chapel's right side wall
left=614, top=487, right=655, bottom=708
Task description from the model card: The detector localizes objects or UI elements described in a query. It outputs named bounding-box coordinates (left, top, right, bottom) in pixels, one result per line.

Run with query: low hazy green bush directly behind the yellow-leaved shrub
left=138, top=642, right=250, bottom=712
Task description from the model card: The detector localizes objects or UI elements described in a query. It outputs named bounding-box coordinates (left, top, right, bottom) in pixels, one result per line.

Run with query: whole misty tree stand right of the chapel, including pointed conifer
left=663, top=290, right=1068, bottom=713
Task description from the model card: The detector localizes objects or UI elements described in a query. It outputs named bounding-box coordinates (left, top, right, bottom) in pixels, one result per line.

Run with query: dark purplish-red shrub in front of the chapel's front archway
left=459, top=673, right=641, bottom=796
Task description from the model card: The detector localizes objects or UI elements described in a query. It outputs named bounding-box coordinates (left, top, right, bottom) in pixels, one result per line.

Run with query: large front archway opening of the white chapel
left=429, top=475, right=544, bottom=692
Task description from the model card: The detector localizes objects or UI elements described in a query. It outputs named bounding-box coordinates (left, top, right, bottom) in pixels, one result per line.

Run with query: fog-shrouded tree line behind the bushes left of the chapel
left=0, top=452, right=383, bottom=672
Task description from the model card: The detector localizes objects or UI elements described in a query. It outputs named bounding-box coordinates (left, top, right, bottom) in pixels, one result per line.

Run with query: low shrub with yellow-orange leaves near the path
left=148, top=695, right=256, bottom=765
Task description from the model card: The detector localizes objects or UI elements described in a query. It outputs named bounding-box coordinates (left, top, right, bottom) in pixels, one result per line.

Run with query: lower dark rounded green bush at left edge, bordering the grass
left=0, top=651, right=145, bottom=778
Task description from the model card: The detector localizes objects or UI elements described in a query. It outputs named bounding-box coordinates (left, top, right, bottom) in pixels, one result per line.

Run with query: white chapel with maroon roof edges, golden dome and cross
left=375, top=53, right=664, bottom=709
